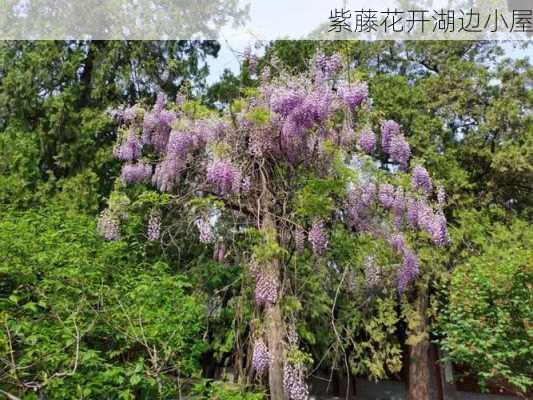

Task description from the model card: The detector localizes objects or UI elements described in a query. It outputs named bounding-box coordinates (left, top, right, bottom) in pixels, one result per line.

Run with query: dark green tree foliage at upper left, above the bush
left=0, top=41, right=219, bottom=211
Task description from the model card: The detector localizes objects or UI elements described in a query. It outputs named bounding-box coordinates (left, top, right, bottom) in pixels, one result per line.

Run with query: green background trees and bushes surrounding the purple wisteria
left=0, top=41, right=533, bottom=400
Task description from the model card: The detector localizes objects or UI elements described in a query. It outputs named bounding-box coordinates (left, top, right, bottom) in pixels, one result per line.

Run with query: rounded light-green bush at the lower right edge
left=440, top=216, right=533, bottom=393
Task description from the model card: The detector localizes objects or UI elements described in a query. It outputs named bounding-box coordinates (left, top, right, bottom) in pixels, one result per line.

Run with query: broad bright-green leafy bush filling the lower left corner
left=0, top=208, right=207, bottom=399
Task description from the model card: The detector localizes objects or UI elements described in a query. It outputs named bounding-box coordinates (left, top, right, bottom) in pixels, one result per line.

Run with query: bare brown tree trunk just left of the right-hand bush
left=407, top=289, right=430, bottom=400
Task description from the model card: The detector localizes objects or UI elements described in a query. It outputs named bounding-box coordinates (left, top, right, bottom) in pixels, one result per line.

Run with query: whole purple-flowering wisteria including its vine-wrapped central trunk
left=99, top=53, right=448, bottom=400
